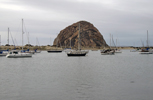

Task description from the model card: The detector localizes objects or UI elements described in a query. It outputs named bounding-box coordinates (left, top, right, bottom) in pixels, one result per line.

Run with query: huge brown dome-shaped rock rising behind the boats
left=54, top=21, right=108, bottom=48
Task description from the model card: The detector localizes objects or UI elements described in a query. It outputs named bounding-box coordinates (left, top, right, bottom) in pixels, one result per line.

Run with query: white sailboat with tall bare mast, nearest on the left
left=6, top=19, right=32, bottom=58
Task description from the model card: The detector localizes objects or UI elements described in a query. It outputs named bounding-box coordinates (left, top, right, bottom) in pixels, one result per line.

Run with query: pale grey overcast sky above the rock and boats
left=0, top=0, right=153, bottom=46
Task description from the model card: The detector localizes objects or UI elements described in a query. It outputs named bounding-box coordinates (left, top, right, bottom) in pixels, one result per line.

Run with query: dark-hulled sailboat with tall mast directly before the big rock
left=67, top=23, right=88, bottom=56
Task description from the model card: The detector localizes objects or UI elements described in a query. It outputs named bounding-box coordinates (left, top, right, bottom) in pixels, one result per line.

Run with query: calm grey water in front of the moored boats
left=0, top=50, right=153, bottom=100
